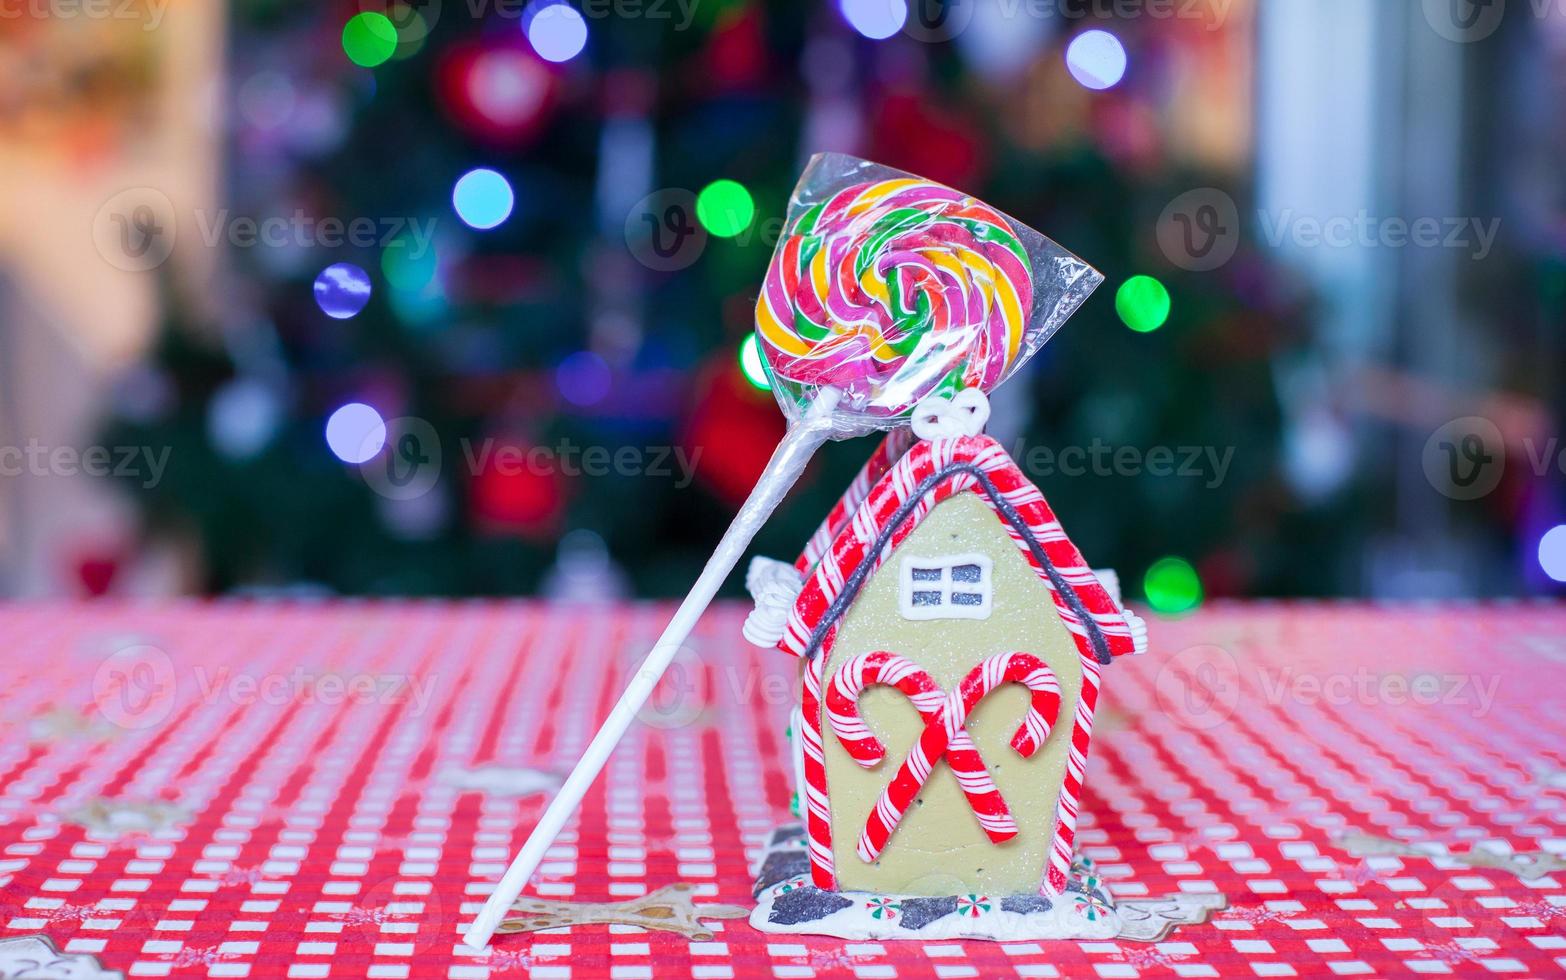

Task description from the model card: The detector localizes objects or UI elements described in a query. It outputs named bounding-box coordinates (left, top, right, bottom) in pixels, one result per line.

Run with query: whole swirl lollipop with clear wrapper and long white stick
left=464, top=153, right=1104, bottom=947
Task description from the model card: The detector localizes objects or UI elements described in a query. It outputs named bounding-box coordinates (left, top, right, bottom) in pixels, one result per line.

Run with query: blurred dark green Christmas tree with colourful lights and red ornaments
left=104, top=0, right=1331, bottom=595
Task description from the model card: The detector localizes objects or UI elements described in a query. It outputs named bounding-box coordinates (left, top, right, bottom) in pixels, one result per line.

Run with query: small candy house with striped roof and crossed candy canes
left=745, top=405, right=1146, bottom=905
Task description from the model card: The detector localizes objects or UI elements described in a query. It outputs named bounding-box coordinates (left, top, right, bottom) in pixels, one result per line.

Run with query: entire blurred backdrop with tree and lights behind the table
left=0, top=0, right=1566, bottom=611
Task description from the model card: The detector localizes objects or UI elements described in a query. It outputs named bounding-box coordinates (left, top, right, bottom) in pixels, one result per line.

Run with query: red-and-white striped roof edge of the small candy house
left=778, top=435, right=1143, bottom=662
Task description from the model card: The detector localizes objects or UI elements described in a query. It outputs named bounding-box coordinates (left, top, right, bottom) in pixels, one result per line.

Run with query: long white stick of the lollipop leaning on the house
left=462, top=388, right=843, bottom=949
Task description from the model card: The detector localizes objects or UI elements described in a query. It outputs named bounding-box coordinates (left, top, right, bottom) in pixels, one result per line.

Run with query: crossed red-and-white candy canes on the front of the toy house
left=827, top=650, right=1060, bottom=863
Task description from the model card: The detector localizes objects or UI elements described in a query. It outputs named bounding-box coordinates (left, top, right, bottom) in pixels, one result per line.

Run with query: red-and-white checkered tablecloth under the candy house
left=0, top=603, right=1566, bottom=978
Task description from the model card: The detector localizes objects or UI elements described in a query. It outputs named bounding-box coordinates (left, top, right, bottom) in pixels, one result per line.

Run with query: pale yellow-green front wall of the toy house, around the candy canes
left=821, top=493, right=1082, bottom=895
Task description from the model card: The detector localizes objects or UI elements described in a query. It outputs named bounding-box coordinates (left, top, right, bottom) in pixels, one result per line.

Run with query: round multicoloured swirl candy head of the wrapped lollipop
left=756, top=178, right=1034, bottom=418
